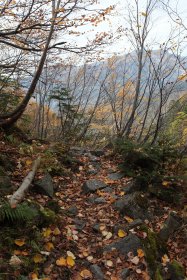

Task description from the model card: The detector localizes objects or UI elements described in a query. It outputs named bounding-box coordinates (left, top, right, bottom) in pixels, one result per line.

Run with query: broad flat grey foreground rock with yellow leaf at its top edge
left=104, top=233, right=142, bottom=255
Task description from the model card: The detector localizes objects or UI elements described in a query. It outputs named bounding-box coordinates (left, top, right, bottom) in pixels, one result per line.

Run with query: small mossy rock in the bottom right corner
left=168, top=260, right=185, bottom=280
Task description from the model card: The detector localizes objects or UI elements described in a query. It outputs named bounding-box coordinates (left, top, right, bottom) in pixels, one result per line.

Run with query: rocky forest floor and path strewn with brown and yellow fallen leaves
left=0, top=142, right=186, bottom=280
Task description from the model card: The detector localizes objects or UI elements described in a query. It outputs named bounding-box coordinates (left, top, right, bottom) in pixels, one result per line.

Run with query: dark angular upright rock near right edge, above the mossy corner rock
left=159, top=212, right=181, bottom=241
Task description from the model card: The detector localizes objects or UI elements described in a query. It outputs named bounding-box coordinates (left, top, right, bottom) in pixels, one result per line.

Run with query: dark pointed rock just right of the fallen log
left=34, top=173, right=54, bottom=197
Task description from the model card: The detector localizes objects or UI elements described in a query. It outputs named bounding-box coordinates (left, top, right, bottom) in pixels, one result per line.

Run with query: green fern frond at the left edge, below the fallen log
left=0, top=201, right=38, bottom=223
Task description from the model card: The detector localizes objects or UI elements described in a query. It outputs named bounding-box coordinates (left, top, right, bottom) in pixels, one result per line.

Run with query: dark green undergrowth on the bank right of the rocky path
left=114, top=140, right=182, bottom=203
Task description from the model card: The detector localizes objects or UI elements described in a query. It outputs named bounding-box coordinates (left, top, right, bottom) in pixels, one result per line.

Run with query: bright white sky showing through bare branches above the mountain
left=68, top=0, right=187, bottom=60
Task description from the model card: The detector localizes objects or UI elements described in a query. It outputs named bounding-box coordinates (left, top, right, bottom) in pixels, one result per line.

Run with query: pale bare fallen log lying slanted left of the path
left=9, top=157, right=41, bottom=207
